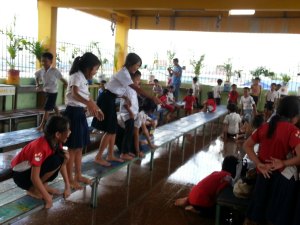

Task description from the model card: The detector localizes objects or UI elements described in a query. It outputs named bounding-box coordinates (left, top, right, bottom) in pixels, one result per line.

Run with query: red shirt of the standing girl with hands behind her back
left=251, top=121, right=300, bottom=162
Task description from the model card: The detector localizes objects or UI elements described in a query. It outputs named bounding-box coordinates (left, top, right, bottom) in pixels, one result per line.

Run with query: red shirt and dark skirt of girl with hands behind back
left=247, top=121, right=300, bottom=225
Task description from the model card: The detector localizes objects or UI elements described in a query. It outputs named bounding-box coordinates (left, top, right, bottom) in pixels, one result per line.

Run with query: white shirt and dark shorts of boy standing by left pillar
left=35, top=67, right=62, bottom=111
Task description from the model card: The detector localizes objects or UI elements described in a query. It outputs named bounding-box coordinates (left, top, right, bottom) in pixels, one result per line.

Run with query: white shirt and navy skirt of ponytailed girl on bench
left=64, top=71, right=90, bottom=149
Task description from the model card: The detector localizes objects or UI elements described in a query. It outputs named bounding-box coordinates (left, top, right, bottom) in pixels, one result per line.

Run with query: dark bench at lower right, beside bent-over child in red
left=215, top=186, right=250, bottom=225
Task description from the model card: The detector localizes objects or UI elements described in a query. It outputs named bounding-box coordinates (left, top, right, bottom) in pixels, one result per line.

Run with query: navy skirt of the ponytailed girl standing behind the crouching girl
left=64, top=106, right=90, bottom=149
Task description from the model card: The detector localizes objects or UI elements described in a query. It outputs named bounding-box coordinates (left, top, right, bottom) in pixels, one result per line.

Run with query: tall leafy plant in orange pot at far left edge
left=0, top=17, right=26, bottom=85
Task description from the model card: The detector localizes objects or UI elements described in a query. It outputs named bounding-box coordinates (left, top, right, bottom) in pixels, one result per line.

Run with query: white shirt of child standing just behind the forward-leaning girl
left=120, top=86, right=139, bottom=121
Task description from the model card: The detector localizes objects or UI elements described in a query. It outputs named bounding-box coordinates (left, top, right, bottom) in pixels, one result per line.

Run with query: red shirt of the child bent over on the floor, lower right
left=189, top=170, right=231, bottom=207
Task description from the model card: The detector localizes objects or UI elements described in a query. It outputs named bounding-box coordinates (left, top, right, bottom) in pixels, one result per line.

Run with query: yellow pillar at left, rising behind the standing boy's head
left=38, top=0, right=57, bottom=65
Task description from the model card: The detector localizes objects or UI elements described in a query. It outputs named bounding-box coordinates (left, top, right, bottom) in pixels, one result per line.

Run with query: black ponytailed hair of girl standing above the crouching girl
left=69, top=52, right=101, bottom=75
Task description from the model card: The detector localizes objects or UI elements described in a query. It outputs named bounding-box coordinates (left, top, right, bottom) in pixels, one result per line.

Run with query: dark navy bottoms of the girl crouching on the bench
left=13, top=153, right=64, bottom=190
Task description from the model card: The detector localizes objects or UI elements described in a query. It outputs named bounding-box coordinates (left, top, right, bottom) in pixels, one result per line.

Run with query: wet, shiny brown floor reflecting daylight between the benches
left=14, top=130, right=243, bottom=225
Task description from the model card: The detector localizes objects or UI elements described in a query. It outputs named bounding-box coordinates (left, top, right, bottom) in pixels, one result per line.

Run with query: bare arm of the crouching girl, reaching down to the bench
left=31, top=166, right=53, bottom=209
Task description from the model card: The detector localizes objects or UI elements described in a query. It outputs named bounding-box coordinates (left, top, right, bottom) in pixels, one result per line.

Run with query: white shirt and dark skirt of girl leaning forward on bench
left=92, top=67, right=133, bottom=134
